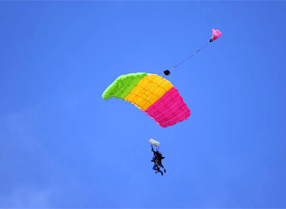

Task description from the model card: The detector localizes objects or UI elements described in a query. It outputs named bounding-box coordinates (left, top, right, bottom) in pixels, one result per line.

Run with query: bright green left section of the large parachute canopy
left=102, top=73, right=147, bottom=100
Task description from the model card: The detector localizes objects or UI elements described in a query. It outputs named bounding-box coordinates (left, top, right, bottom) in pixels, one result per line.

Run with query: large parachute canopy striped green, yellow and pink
left=102, top=73, right=191, bottom=128
